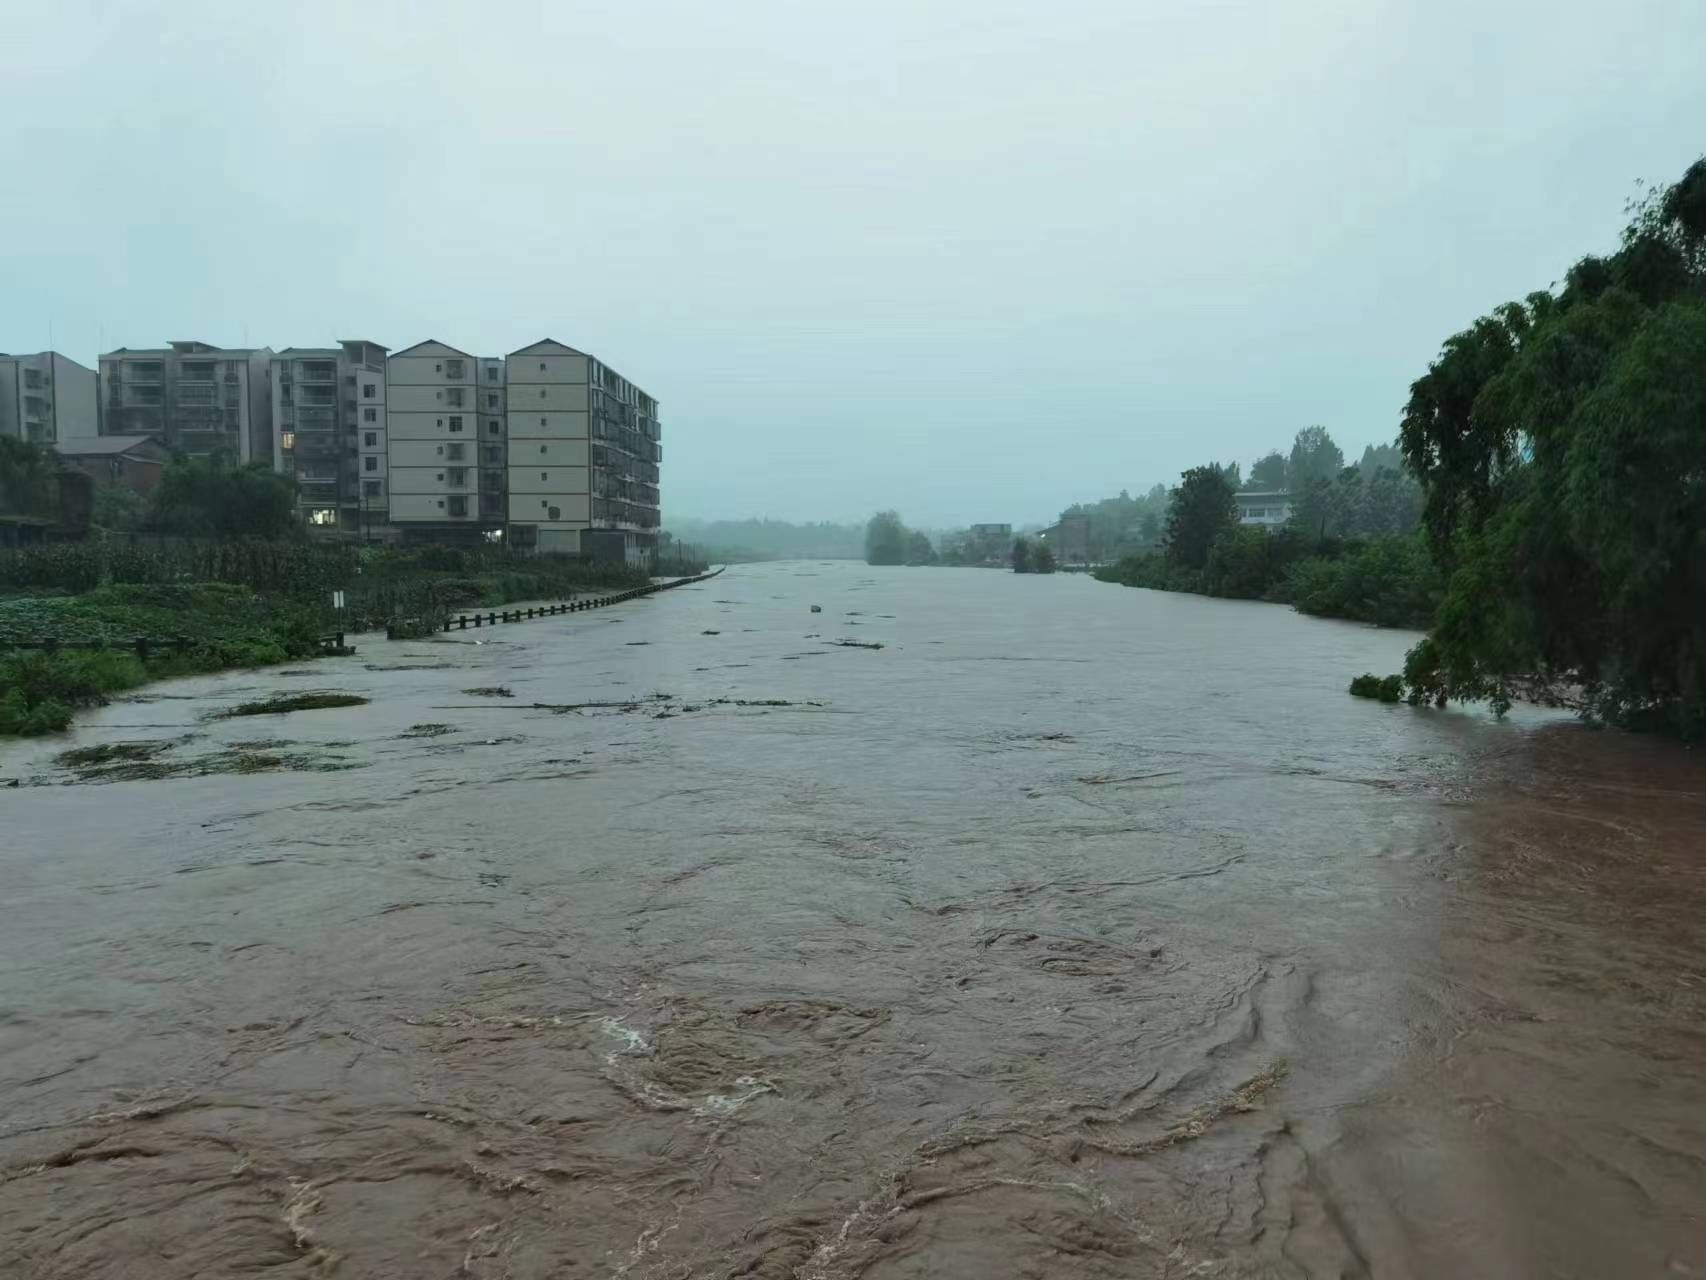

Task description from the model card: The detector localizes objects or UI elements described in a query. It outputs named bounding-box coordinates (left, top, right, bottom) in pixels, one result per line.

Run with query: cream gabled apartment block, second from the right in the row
left=386, top=341, right=503, bottom=539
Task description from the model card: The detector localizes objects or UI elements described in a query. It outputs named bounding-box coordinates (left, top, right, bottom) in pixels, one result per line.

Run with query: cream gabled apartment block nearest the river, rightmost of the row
left=505, top=338, right=664, bottom=563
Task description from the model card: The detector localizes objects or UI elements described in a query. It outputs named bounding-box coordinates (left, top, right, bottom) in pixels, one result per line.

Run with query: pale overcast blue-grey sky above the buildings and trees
left=0, top=0, right=1706, bottom=526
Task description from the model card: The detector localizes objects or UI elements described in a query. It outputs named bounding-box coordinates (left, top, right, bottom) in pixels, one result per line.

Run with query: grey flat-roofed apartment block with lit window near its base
left=270, top=338, right=389, bottom=536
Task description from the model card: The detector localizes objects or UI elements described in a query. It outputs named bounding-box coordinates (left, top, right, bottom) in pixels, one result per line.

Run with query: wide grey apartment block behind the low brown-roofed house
left=101, top=341, right=273, bottom=463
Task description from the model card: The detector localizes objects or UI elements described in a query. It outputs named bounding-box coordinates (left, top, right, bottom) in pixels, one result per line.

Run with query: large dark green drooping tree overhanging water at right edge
left=1401, top=160, right=1706, bottom=737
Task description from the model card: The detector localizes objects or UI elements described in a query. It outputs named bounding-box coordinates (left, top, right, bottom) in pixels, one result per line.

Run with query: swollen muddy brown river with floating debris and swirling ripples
left=0, top=563, right=1706, bottom=1280
